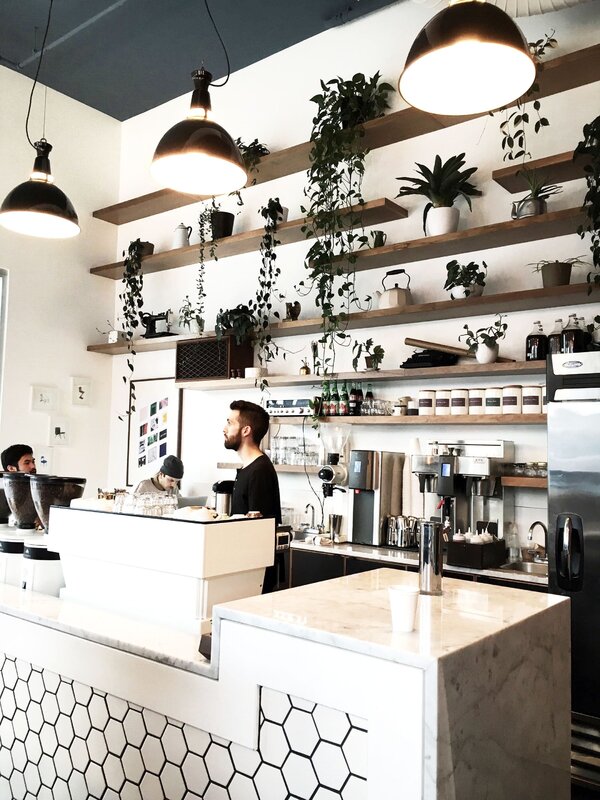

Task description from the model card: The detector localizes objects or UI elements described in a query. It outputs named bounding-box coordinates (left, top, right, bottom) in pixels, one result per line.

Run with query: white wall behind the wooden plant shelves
left=103, top=2, right=600, bottom=548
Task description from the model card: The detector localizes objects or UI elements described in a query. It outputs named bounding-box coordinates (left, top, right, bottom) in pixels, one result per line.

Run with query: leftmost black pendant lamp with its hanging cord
left=0, top=0, right=80, bottom=239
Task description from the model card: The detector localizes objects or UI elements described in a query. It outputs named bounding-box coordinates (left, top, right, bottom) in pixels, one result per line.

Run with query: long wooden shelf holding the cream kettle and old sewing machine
left=87, top=283, right=600, bottom=354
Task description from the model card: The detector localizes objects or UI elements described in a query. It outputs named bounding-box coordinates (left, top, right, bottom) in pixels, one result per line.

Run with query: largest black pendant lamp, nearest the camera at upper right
left=398, top=0, right=535, bottom=115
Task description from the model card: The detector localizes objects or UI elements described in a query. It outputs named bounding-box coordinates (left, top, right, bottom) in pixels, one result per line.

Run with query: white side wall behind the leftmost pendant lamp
left=0, top=67, right=120, bottom=493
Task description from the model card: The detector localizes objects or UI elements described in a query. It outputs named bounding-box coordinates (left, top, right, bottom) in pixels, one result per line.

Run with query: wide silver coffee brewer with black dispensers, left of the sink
left=411, top=440, right=514, bottom=538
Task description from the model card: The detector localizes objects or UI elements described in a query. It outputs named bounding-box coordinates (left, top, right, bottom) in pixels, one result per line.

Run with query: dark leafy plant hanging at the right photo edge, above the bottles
left=573, top=116, right=600, bottom=291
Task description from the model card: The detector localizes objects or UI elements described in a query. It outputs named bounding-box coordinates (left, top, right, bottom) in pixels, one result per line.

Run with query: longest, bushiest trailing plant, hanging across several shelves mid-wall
left=298, top=72, right=394, bottom=376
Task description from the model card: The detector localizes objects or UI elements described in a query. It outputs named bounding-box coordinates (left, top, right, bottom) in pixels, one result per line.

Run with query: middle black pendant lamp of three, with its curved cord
left=151, top=0, right=248, bottom=196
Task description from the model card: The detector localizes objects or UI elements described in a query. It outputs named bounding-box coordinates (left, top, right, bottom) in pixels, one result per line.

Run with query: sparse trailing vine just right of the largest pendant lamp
left=490, top=31, right=558, bottom=161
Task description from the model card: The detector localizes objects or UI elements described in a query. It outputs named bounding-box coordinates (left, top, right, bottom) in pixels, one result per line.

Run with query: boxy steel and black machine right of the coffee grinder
left=348, top=450, right=404, bottom=545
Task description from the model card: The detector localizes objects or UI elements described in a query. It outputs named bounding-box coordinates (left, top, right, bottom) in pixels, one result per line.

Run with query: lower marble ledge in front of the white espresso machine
left=0, top=584, right=216, bottom=677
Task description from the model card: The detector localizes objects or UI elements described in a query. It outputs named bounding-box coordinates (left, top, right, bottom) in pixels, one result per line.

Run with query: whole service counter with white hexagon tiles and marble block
left=0, top=570, right=570, bottom=800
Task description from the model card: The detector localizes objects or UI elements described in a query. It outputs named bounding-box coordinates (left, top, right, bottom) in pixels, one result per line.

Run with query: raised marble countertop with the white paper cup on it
left=213, top=569, right=568, bottom=668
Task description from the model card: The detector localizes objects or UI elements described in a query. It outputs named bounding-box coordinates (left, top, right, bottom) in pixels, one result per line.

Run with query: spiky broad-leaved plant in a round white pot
left=396, top=153, right=482, bottom=236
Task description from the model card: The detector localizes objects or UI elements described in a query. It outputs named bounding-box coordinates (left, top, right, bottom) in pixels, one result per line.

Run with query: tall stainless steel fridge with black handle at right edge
left=546, top=352, right=600, bottom=786
